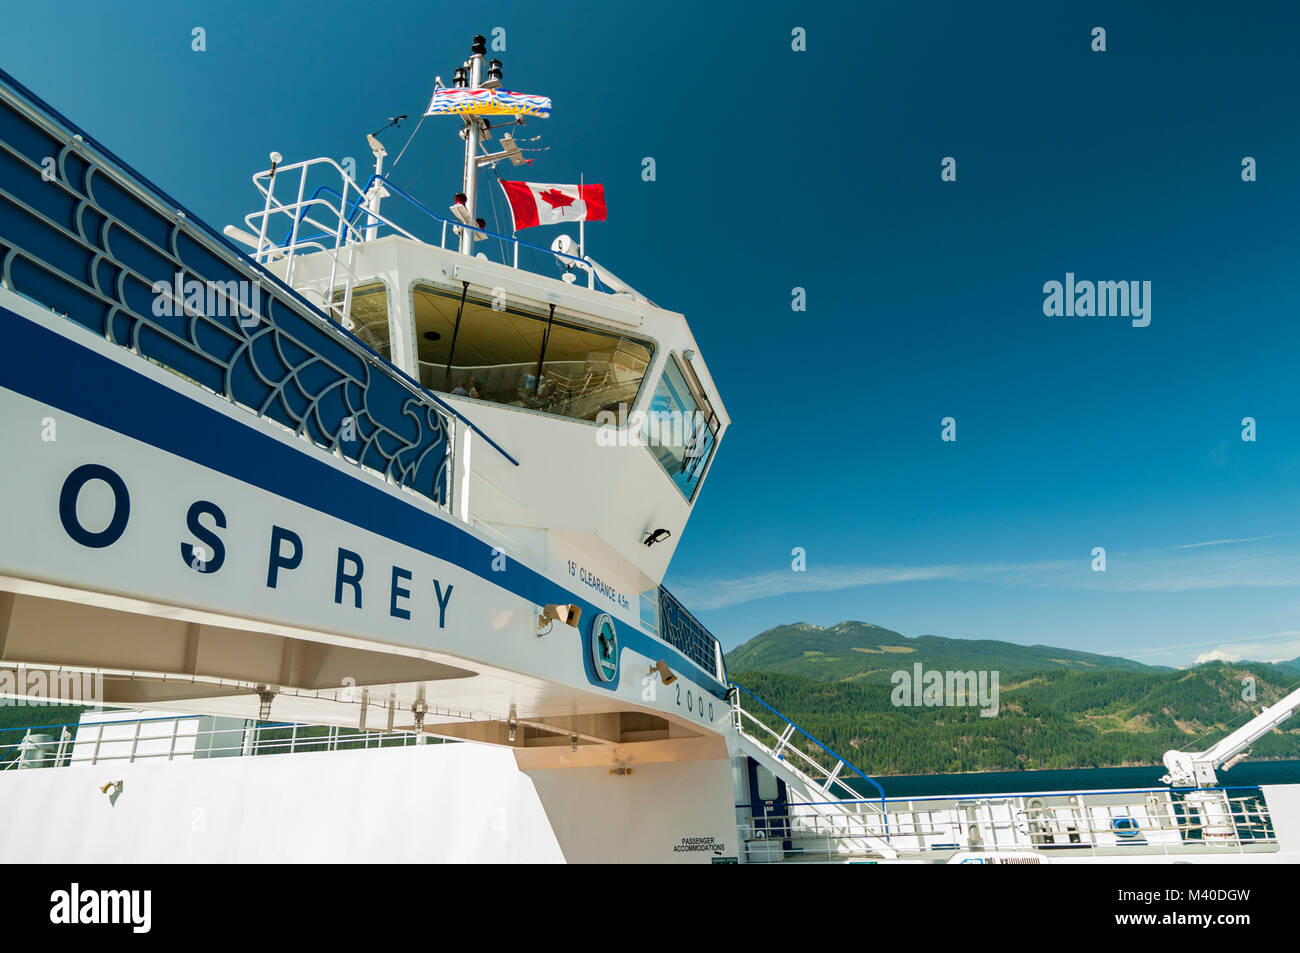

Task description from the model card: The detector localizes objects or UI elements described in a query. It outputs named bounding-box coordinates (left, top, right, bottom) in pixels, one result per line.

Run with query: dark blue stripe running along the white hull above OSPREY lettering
left=0, top=307, right=725, bottom=698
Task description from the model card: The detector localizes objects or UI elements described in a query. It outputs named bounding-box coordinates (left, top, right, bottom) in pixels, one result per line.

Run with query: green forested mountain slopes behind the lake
left=727, top=623, right=1300, bottom=775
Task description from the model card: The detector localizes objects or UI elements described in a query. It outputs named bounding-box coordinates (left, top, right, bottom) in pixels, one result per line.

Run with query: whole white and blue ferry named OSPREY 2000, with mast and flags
left=0, top=36, right=1300, bottom=863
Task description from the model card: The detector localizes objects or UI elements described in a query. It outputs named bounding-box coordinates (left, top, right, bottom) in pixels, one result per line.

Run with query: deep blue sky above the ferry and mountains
left=0, top=0, right=1300, bottom=664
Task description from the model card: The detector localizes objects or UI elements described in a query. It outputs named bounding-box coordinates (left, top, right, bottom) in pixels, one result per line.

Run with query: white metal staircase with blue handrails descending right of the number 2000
left=731, top=683, right=898, bottom=859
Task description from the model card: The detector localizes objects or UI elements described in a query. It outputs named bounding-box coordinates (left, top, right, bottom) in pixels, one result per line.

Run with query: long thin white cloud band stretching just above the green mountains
left=675, top=536, right=1300, bottom=610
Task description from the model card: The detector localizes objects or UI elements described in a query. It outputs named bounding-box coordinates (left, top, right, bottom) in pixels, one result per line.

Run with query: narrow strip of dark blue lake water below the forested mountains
left=854, top=761, right=1300, bottom=797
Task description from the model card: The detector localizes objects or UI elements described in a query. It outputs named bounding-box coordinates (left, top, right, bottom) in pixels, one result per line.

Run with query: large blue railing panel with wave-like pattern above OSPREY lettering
left=0, top=83, right=452, bottom=507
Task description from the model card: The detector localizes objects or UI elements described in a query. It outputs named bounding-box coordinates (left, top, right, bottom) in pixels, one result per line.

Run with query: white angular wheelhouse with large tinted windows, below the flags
left=247, top=167, right=728, bottom=603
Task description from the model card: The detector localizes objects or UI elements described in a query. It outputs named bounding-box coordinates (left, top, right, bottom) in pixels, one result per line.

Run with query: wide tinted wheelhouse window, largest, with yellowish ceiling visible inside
left=413, top=285, right=654, bottom=420
